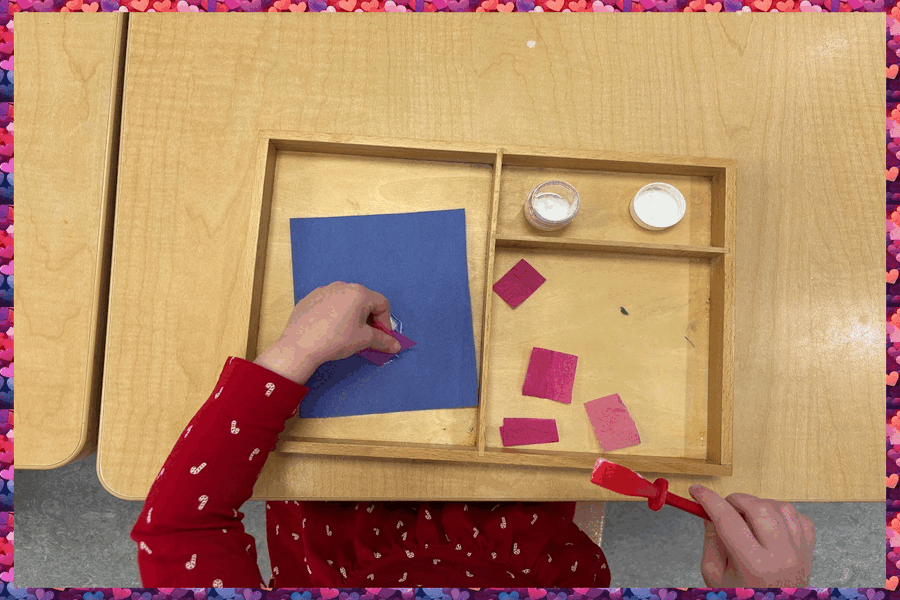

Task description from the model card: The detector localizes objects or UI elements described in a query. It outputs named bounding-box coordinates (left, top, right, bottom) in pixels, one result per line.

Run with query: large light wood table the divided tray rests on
left=98, top=14, right=884, bottom=501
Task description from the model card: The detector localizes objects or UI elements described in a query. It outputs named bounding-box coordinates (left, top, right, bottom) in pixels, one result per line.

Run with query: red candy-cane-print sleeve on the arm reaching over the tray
left=131, top=357, right=309, bottom=588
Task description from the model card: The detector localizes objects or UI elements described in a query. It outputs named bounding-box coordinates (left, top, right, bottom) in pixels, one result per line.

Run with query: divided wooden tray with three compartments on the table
left=247, top=131, right=737, bottom=476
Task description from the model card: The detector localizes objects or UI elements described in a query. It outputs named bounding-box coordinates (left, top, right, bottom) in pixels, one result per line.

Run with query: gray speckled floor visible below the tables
left=15, top=456, right=885, bottom=588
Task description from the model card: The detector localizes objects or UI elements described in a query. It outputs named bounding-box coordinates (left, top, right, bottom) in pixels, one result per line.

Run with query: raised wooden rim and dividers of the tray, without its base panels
left=246, top=131, right=737, bottom=476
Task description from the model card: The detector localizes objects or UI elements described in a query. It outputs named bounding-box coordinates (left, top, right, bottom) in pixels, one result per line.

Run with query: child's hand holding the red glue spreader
left=690, top=485, right=816, bottom=588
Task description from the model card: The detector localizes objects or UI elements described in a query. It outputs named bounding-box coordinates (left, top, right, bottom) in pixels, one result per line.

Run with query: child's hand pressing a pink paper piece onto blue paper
left=254, top=281, right=400, bottom=383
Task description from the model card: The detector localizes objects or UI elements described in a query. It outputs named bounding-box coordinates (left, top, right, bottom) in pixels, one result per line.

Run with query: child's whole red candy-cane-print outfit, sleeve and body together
left=131, top=357, right=609, bottom=588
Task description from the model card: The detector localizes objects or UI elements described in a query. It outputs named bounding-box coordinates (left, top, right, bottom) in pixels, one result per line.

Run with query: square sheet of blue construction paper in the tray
left=290, top=209, right=478, bottom=418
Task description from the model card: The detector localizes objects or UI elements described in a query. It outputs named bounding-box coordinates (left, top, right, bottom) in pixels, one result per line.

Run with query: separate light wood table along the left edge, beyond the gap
left=14, top=12, right=125, bottom=469
